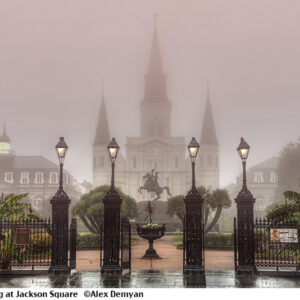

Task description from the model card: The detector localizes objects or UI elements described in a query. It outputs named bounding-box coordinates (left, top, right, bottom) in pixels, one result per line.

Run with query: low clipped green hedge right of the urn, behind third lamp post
left=172, top=233, right=234, bottom=250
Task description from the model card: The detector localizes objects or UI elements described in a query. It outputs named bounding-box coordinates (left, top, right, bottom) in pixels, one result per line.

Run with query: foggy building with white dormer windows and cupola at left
left=0, top=126, right=82, bottom=217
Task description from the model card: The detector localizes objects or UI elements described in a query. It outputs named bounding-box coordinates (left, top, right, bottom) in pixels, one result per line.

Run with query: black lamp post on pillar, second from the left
left=101, top=138, right=122, bottom=272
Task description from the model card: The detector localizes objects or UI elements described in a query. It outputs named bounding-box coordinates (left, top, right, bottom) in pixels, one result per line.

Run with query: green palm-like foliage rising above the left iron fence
left=0, top=193, right=40, bottom=221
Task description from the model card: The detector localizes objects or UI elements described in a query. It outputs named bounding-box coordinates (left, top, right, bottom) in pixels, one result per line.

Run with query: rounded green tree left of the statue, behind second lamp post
left=72, top=185, right=138, bottom=233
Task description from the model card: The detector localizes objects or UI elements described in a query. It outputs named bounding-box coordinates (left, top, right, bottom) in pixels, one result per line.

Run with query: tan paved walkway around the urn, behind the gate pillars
left=76, top=236, right=234, bottom=270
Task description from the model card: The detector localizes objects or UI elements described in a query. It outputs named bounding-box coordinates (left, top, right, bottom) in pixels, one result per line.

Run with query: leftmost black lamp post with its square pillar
left=50, top=137, right=71, bottom=273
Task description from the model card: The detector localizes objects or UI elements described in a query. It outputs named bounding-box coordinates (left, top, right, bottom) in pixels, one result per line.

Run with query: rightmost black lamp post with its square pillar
left=235, top=138, right=256, bottom=274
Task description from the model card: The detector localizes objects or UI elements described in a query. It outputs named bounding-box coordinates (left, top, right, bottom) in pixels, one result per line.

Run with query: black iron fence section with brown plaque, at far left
left=0, top=219, right=52, bottom=270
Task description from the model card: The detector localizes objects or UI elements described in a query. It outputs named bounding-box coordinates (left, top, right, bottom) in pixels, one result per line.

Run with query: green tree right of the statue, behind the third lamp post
left=167, top=186, right=231, bottom=233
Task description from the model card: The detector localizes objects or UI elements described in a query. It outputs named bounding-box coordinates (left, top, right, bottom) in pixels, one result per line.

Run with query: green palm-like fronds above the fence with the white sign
left=267, top=191, right=300, bottom=222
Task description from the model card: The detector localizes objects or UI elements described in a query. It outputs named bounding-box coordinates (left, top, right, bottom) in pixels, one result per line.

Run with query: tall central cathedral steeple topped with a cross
left=141, top=16, right=171, bottom=137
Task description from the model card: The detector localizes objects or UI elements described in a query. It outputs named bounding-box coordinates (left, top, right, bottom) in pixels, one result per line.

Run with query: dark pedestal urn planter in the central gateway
left=136, top=224, right=166, bottom=258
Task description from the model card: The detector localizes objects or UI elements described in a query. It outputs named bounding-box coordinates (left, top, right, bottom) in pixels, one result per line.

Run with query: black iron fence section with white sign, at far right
left=254, top=219, right=300, bottom=271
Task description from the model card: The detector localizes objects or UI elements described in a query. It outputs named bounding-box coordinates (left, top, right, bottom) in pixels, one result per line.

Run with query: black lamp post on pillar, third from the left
left=183, top=137, right=204, bottom=274
